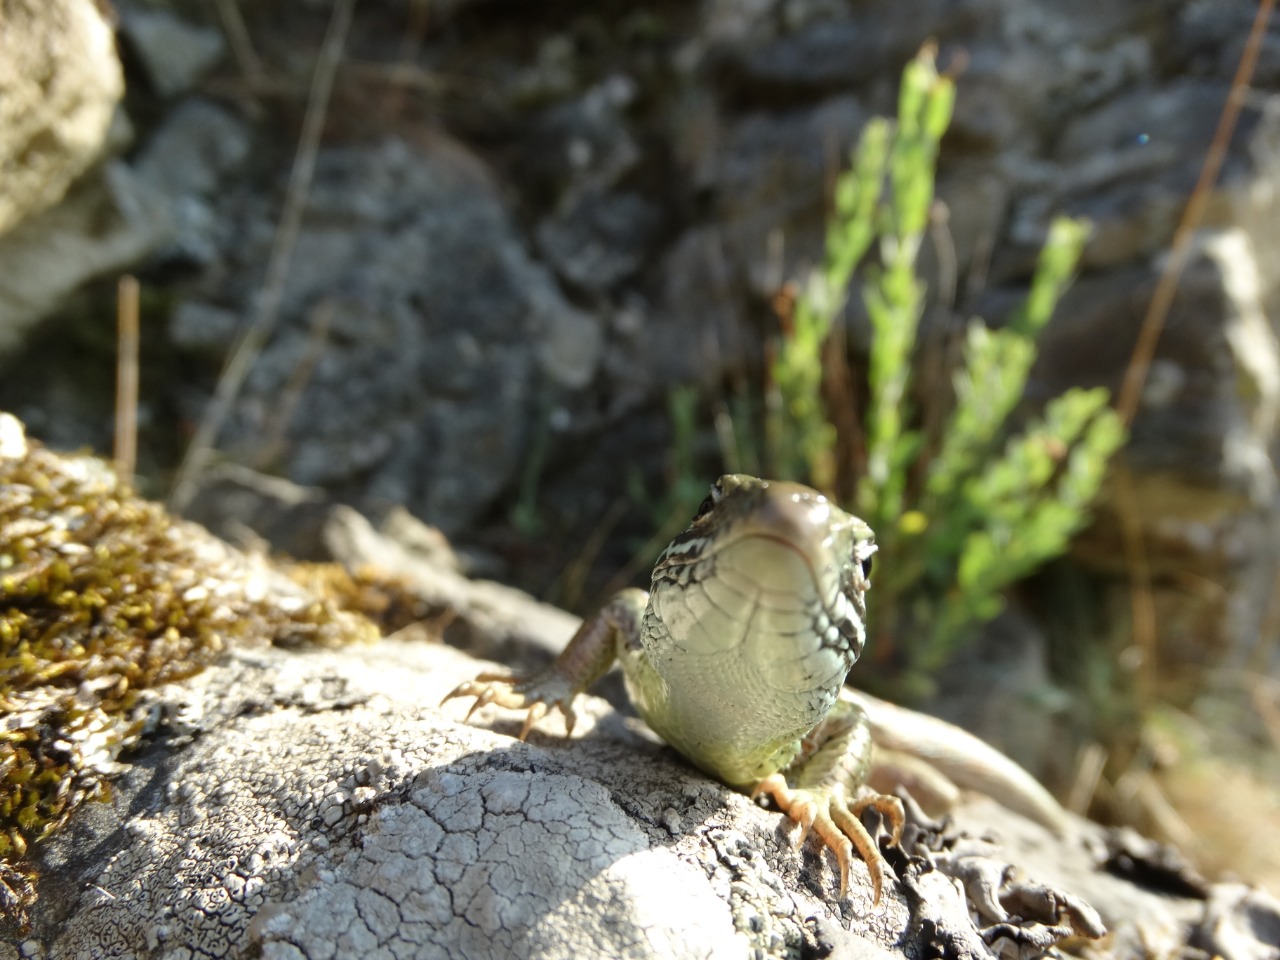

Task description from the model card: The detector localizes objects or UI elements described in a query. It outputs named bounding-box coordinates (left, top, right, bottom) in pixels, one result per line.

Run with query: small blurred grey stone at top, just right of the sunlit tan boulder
left=120, top=4, right=227, bottom=97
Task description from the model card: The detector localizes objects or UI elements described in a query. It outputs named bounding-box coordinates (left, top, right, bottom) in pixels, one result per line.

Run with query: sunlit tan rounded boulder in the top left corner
left=0, top=0, right=124, bottom=239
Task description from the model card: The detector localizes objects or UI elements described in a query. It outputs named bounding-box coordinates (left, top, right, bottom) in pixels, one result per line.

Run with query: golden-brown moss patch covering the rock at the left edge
left=0, top=413, right=378, bottom=931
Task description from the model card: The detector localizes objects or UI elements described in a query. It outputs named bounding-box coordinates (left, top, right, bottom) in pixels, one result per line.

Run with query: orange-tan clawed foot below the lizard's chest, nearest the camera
left=751, top=773, right=905, bottom=906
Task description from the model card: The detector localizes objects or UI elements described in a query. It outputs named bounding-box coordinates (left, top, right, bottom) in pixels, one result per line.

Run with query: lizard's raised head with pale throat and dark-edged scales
left=650, top=474, right=876, bottom=690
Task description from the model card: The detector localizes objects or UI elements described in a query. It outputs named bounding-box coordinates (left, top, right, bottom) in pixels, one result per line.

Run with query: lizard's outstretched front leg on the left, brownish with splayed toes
left=440, top=589, right=649, bottom=740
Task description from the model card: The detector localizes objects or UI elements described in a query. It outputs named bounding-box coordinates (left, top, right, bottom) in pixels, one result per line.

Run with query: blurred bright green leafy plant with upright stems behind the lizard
left=765, top=47, right=1125, bottom=689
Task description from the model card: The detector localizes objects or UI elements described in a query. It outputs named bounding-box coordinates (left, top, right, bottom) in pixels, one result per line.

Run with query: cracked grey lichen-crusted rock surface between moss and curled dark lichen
left=26, top=641, right=870, bottom=957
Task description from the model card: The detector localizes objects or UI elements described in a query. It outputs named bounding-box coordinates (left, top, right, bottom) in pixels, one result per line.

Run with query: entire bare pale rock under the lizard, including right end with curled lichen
left=0, top=499, right=1280, bottom=960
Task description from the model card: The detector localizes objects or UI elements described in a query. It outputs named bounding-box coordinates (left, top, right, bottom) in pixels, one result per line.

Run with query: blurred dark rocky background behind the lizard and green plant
left=0, top=0, right=1280, bottom=885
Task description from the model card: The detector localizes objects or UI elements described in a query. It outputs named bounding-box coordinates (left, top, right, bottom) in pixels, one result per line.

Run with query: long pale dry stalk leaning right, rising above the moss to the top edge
left=169, top=0, right=356, bottom=512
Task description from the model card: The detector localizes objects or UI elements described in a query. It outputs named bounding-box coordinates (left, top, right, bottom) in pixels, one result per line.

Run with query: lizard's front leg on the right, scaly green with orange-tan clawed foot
left=751, top=701, right=904, bottom=905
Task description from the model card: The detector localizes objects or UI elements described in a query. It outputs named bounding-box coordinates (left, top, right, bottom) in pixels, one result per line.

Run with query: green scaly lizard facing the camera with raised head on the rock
left=444, top=474, right=1065, bottom=906
